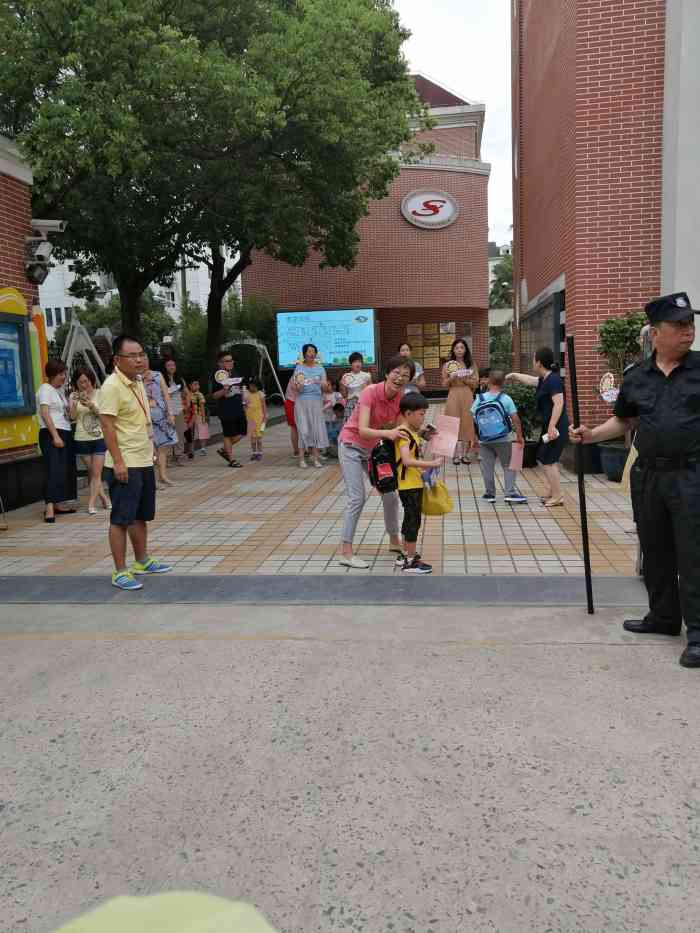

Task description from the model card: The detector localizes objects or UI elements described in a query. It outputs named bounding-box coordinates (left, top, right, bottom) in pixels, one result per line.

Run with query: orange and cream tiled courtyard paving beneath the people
left=0, top=414, right=636, bottom=576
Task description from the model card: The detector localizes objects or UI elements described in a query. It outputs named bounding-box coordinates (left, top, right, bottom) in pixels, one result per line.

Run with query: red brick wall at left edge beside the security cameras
left=0, top=174, right=39, bottom=308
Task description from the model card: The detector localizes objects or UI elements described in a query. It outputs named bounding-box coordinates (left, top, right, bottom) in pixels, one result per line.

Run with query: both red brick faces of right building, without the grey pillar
left=513, top=0, right=665, bottom=421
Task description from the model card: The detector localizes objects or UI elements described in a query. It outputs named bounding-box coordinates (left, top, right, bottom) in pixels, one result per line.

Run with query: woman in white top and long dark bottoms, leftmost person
left=37, top=360, right=78, bottom=525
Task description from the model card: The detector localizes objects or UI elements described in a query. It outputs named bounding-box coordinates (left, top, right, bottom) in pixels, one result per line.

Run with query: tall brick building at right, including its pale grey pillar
left=512, top=0, right=700, bottom=422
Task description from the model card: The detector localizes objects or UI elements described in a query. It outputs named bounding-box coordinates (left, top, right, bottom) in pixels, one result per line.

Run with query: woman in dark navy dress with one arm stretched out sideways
left=507, top=347, right=569, bottom=508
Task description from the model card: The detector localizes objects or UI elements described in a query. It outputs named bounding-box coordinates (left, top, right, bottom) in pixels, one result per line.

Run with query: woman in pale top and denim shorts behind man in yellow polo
left=68, top=367, right=109, bottom=515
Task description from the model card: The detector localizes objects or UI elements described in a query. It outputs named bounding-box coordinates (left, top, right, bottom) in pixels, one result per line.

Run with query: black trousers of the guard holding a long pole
left=630, top=464, right=700, bottom=643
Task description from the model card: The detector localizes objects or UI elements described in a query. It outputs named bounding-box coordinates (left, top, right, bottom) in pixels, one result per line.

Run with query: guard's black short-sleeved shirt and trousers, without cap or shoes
left=615, top=350, right=700, bottom=643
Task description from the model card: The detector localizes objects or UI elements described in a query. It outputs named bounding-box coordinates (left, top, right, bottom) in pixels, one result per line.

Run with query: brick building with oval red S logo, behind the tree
left=243, top=76, right=490, bottom=388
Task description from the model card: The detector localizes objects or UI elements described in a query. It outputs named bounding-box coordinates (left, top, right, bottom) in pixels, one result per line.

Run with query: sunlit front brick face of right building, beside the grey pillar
left=567, top=0, right=665, bottom=419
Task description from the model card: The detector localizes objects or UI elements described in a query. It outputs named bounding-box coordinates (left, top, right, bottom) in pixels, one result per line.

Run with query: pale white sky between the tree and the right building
left=394, top=0, right=513, bottom=243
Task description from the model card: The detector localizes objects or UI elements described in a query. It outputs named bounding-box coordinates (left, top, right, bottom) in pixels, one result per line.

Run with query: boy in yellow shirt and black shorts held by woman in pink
left=395, top=392, right=442, bottom=574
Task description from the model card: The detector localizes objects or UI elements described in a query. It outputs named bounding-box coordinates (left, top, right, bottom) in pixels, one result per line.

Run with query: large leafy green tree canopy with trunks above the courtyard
left=0, top=0, right=425, bottom=342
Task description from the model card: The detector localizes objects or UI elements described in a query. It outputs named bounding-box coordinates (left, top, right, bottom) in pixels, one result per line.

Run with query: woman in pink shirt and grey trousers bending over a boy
left=338, top=356, right=415, bottom=570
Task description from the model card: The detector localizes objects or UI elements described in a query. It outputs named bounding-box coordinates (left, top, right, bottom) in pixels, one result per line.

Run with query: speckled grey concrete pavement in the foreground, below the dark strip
left=0, top=596, right=700, bottom=933
